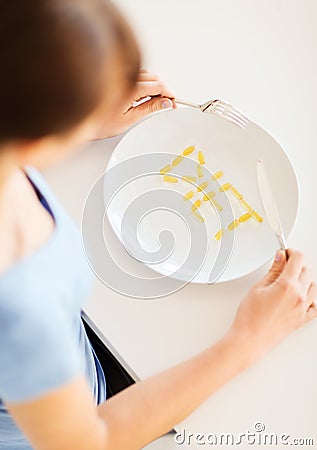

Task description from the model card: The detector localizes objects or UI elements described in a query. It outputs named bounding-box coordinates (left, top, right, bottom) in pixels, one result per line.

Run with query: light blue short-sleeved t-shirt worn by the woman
left=0, top=169, right=106, bottom=450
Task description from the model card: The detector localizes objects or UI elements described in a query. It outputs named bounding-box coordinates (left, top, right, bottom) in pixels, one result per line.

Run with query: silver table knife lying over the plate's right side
left=257, top=160, right=288, bottom=258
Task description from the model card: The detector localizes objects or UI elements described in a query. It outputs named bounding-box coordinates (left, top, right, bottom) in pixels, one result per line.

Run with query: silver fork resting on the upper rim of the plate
left=174, top=98, right=249, bottom=129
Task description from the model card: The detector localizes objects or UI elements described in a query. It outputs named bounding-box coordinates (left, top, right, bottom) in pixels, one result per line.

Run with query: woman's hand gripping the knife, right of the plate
left=229, top=250, right=317, bottom=359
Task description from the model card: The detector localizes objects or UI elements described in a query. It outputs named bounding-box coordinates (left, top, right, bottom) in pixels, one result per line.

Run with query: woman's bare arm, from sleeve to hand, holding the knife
left=9, top=251, right=317, bottom=450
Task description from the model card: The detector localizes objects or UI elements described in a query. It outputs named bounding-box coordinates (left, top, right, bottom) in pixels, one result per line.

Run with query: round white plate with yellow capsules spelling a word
left=105, top=108, right=299, bottom=283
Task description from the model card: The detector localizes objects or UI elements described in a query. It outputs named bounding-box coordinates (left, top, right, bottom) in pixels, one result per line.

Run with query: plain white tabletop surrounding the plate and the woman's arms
left=46, top=0, right=317, bottom=449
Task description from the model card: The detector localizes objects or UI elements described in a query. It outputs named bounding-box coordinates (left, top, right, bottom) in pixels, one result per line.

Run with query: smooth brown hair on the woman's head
left=0, top=0, right=140, bottom=141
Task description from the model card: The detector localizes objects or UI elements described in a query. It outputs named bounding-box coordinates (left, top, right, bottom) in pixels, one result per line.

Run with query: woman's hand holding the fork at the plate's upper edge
left=94, top=69, right=176, bottom=139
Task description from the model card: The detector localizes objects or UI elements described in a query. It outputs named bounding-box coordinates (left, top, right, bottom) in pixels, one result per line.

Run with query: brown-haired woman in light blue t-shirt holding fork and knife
left=0, top=0, right=317, bottom=450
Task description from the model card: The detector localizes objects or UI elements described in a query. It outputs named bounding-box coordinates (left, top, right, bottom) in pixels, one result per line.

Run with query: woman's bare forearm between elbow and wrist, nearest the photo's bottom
left=98, top=328, right=251, bottom=450
